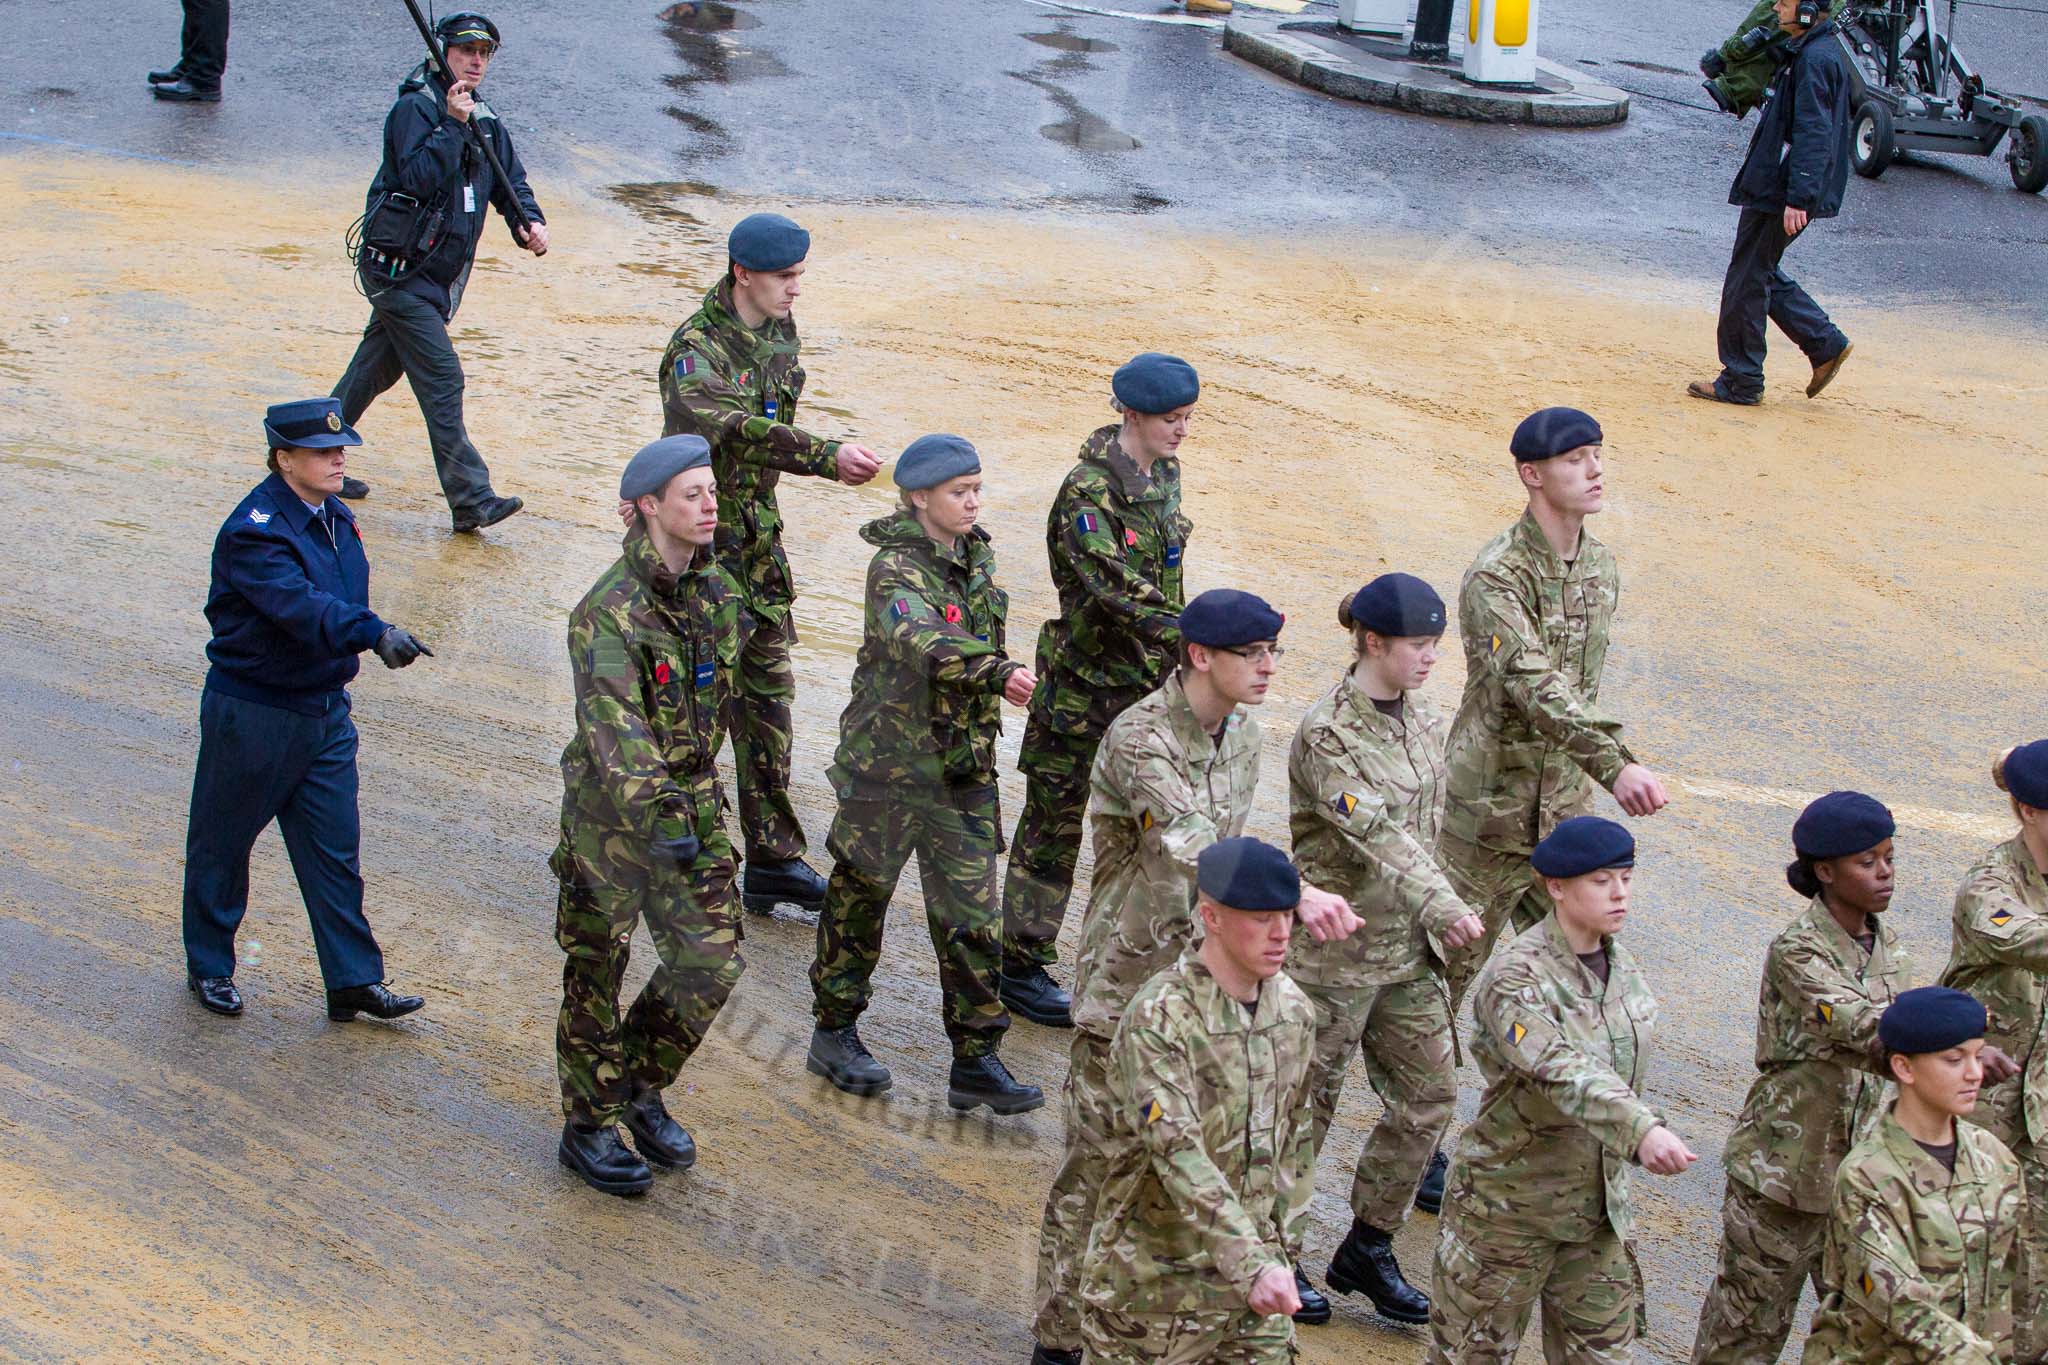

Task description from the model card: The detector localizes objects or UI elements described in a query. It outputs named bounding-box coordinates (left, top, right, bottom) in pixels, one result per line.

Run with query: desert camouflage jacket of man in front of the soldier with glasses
left=1081, top=945, right=1315, bottom=1316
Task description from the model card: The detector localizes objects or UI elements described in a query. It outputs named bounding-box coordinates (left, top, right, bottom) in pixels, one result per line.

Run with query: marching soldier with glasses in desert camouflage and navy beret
left=1032, top=587, right=1358, bottom=1365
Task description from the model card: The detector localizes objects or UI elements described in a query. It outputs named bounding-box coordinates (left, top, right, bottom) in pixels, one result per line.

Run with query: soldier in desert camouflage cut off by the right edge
left=1942, top=739, right=2048, bottom=1361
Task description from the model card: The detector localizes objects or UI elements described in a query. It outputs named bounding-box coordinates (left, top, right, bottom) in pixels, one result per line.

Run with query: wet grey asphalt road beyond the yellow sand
left=0, top=0, right=2048, bottom=321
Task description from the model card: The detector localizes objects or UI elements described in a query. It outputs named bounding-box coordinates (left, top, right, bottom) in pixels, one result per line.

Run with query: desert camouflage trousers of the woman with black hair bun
left=1692, top=1181, right=1827, bottom=1365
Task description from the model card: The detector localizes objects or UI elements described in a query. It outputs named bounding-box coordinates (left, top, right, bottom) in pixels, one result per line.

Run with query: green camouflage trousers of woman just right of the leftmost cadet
left=811, top=786, right=1010, bottom=1058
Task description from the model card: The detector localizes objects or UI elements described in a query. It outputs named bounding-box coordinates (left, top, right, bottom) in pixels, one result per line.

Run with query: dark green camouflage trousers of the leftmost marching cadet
left=549, top=827, right=745, bottom=1124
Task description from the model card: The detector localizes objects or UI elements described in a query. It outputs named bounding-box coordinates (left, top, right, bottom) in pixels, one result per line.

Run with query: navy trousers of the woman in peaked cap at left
left=184, top=688, right=383, bottom=990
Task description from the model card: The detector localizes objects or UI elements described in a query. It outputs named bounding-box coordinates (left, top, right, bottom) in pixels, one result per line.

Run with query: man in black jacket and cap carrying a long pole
left=334, top=14, right=547, bottom=530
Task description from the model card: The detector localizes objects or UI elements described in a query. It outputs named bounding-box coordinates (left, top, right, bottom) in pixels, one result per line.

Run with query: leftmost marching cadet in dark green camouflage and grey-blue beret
left=549, top=436, right=745, bottom=1195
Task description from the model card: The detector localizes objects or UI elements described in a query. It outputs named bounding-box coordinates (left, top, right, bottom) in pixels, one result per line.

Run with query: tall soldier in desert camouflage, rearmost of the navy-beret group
left=1438, top=407, right=1665, bottom=1009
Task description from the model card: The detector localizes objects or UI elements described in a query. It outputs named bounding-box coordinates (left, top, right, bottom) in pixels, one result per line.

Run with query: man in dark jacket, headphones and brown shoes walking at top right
left=1686, top=0, right=1849, bottom=405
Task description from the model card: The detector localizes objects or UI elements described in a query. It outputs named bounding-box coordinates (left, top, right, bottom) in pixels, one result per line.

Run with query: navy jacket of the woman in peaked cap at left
left=207, top=475, right=385, bottom=716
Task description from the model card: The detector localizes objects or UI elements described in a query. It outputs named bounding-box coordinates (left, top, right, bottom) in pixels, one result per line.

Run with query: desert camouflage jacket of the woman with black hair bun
left=1722, top=896, right=1913, bottom=1214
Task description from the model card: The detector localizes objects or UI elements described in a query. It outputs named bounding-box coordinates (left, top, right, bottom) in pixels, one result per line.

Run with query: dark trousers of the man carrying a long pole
left=334, top=289, right=492, bottom=512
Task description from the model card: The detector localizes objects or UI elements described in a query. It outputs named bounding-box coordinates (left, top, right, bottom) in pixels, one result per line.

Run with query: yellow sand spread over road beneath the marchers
left=0, top=156, right=2048, bottom=1361
